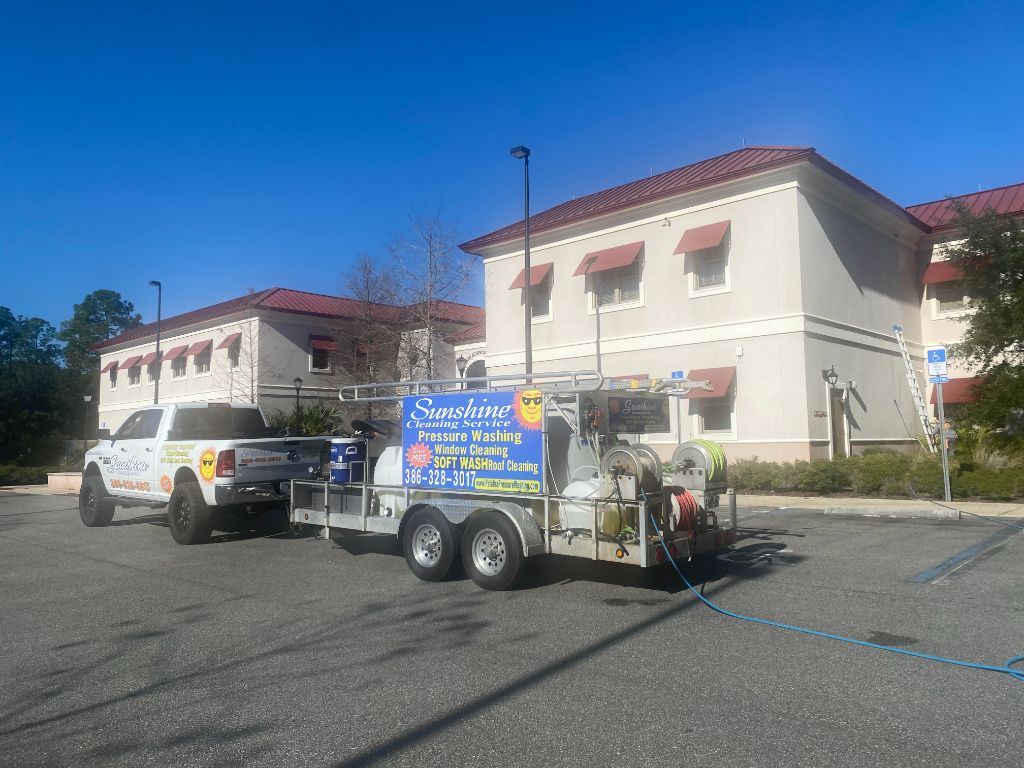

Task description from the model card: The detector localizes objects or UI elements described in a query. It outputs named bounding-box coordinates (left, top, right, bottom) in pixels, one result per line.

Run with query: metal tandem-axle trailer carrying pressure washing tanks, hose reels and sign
left=290, top=372, right=736, bottom=590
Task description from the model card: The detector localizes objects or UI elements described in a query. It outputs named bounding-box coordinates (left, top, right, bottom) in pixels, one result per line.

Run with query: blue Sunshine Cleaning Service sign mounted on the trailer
left=401, top=389, right=544, bottom=494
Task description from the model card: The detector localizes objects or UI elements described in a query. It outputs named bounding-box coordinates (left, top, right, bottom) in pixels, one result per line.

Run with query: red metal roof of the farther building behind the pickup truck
left=90, top=288, right=483, bottom=359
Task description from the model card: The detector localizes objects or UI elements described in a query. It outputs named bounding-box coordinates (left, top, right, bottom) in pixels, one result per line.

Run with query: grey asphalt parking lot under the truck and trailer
left=0, top=493, right=1024, bottom=768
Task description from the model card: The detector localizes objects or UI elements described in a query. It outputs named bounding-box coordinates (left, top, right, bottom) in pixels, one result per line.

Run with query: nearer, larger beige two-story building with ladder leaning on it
left=463, top=147, right=1024, bottom=460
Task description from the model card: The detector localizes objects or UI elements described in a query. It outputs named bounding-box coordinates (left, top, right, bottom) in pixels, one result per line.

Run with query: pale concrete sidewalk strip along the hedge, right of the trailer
left=736, top=494, right=1024, bottom=520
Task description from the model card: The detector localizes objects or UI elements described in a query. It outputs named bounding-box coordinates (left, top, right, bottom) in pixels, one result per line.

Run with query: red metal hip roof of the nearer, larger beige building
left=460, top=146, right=927, bottom=253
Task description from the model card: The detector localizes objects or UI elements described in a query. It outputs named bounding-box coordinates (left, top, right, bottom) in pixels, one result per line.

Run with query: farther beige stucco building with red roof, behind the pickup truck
left=93, top=288, right=483, bottom=430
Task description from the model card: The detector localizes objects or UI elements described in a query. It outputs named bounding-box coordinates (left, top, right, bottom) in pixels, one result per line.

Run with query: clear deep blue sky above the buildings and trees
left=0, top=0, right=1024, bottom=325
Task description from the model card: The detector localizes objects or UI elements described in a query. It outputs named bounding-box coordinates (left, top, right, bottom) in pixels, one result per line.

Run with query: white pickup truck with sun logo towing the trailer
left=79, top=402, right=329, bottom=544
